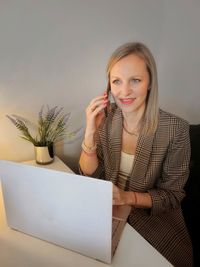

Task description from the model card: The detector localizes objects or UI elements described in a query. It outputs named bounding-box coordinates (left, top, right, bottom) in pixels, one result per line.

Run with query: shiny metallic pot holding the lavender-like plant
left=35, top=144, right=54, bottom=165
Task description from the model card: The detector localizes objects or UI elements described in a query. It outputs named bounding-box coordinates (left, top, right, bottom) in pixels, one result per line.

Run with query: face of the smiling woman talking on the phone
left=110, top=54, right=150, bottom=116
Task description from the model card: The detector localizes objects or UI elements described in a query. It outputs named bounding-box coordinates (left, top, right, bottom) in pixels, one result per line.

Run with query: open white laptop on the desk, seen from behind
left=0, top=160, right=130, bottom=263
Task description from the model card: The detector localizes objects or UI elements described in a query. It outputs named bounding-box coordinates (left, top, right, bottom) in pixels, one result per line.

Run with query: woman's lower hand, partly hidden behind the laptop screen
left=113, top=184, right=131, bottom=205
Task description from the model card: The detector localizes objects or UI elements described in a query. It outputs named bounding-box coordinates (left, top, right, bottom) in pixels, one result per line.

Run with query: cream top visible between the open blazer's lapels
left=118, top=151, right=135, bottom=189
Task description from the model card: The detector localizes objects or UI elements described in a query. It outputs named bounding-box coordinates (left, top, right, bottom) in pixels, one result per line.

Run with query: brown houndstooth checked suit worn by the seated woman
left=86, top=105, right=192, bottom=267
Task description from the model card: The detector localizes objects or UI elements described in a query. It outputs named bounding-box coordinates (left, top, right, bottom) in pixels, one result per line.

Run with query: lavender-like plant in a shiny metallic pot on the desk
left=7, top=106, right=78, bottom=164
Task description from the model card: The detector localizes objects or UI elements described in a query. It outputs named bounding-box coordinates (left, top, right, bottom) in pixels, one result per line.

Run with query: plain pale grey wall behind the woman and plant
left=0, top=0, right=200, bottom=170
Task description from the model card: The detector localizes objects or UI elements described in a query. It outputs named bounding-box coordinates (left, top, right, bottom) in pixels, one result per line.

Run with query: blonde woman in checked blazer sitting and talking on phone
left=80, top=43, right=192, bottom=267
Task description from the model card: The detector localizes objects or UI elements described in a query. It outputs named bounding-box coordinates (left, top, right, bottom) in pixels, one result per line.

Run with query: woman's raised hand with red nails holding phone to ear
left=85, top=93, right=108, bottom=136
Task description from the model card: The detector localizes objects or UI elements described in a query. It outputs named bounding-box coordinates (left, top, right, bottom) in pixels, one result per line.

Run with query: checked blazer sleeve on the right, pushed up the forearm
left=148, top=120, right=191, bottom=215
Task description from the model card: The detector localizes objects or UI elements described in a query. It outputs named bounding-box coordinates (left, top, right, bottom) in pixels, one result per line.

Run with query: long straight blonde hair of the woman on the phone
left=106, top=42, right=158, bottom=133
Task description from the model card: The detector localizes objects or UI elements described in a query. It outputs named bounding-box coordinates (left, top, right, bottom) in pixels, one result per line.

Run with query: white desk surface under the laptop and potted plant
left=0, top=157, right=172, bottom=267
